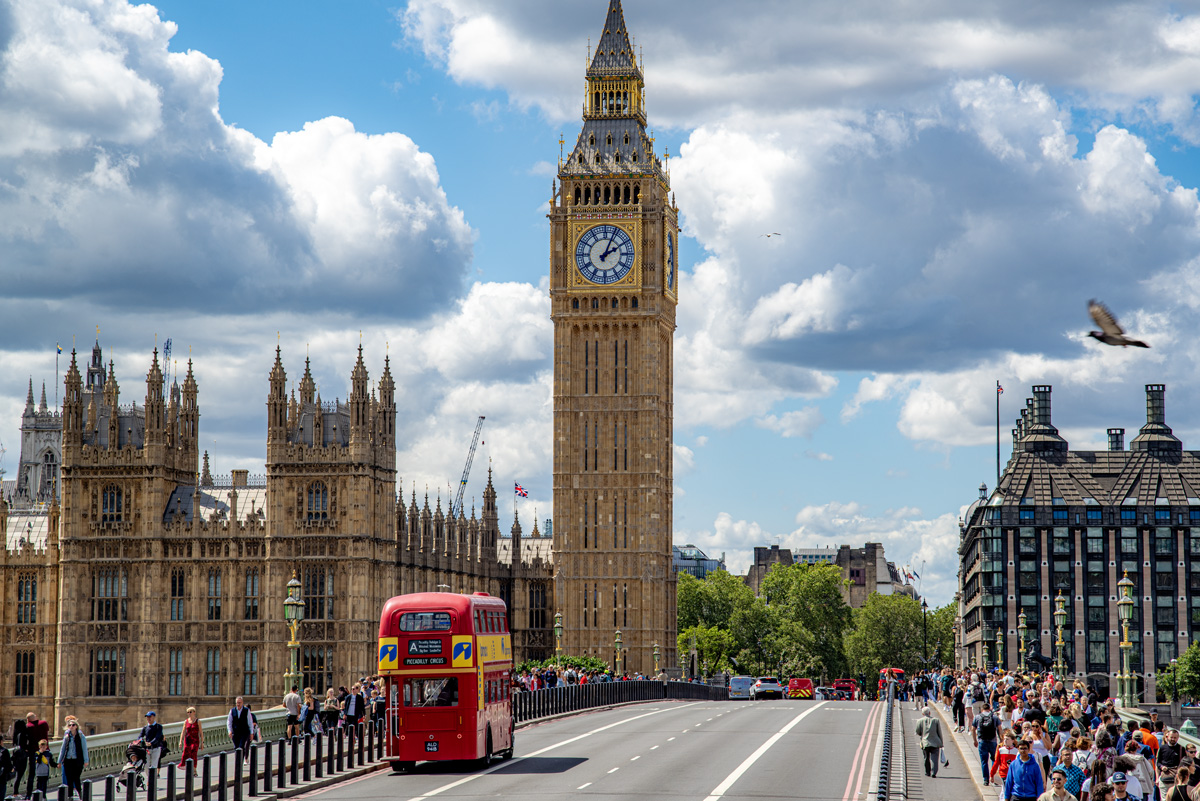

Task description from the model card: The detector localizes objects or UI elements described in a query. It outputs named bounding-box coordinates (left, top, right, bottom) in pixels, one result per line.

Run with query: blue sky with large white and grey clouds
left=0, top=0, right=1200, bottom=604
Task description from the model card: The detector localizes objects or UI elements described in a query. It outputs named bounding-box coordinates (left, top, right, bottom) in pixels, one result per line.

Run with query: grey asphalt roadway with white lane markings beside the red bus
left=292, top=700, right=882, bottom=801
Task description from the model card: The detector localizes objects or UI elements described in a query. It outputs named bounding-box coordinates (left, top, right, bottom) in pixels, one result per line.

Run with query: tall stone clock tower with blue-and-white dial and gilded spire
left=550, top=0, right=679, bottom=673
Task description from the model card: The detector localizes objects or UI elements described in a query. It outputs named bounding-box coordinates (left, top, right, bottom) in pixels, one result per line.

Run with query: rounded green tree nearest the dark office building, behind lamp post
left=846, top=592, right=923, bottom=677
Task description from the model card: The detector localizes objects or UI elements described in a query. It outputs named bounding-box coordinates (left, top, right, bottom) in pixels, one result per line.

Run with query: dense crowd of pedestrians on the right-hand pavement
left=901, top=668, right=1200, bottom=801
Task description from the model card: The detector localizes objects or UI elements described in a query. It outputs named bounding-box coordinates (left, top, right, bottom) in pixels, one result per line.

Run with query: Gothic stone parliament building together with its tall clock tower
left=0, top=0, right=679, bottom=731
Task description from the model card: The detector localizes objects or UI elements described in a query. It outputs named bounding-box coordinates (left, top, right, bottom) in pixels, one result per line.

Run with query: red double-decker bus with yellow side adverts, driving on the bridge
left=379, top=592, right=514, bottom=771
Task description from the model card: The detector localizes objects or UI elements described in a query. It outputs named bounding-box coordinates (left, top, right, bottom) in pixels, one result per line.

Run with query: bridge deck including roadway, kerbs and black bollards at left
left=21, top=682, right=996, bottom=801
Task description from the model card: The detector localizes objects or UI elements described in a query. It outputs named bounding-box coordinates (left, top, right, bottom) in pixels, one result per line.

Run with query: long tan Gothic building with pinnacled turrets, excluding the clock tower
left=0, top=343, right=553, bottom=731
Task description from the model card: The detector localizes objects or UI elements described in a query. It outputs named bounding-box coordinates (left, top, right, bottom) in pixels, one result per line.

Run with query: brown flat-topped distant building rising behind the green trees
left=746, top=542, right=917, bottom=609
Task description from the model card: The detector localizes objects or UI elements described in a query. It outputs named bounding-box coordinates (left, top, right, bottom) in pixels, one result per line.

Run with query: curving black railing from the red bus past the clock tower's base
left=512, top=681, right=728, bottom=723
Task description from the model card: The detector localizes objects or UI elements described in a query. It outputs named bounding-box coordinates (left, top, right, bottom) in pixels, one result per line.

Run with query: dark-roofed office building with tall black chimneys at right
left=959, top=384, right=1200, bottom=699
